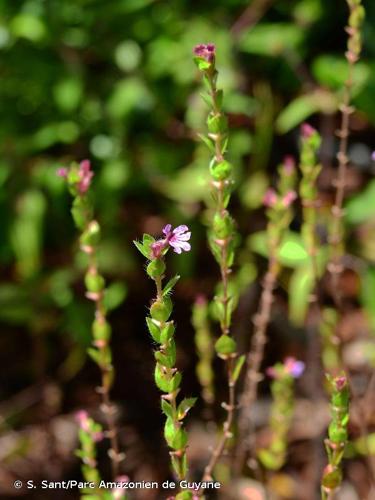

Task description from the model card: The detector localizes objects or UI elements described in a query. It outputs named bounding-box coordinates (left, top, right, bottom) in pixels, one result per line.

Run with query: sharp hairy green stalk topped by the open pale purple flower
left=134, top=224, right=196, bottom=492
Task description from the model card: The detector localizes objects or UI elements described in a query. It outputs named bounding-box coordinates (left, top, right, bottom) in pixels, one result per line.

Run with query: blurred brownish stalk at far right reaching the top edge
left=328, top=0, right=365, bottom=305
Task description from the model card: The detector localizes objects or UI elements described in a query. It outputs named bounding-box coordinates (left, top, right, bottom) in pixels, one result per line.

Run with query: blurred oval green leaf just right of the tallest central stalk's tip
left=239, top=23, right=304, bottom=57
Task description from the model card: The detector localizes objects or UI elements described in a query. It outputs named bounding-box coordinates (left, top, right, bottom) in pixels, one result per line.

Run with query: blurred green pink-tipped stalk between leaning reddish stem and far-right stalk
left=299, top=123, right=322, bottom=285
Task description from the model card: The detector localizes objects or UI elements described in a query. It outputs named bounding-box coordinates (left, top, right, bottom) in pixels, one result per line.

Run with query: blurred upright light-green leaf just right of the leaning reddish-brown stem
left=289, top=266, right=314, bottom=326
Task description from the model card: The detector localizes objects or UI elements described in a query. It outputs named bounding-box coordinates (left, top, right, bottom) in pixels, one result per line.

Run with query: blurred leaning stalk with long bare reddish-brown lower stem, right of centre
left=235, top=158, right=297, bottom=474
